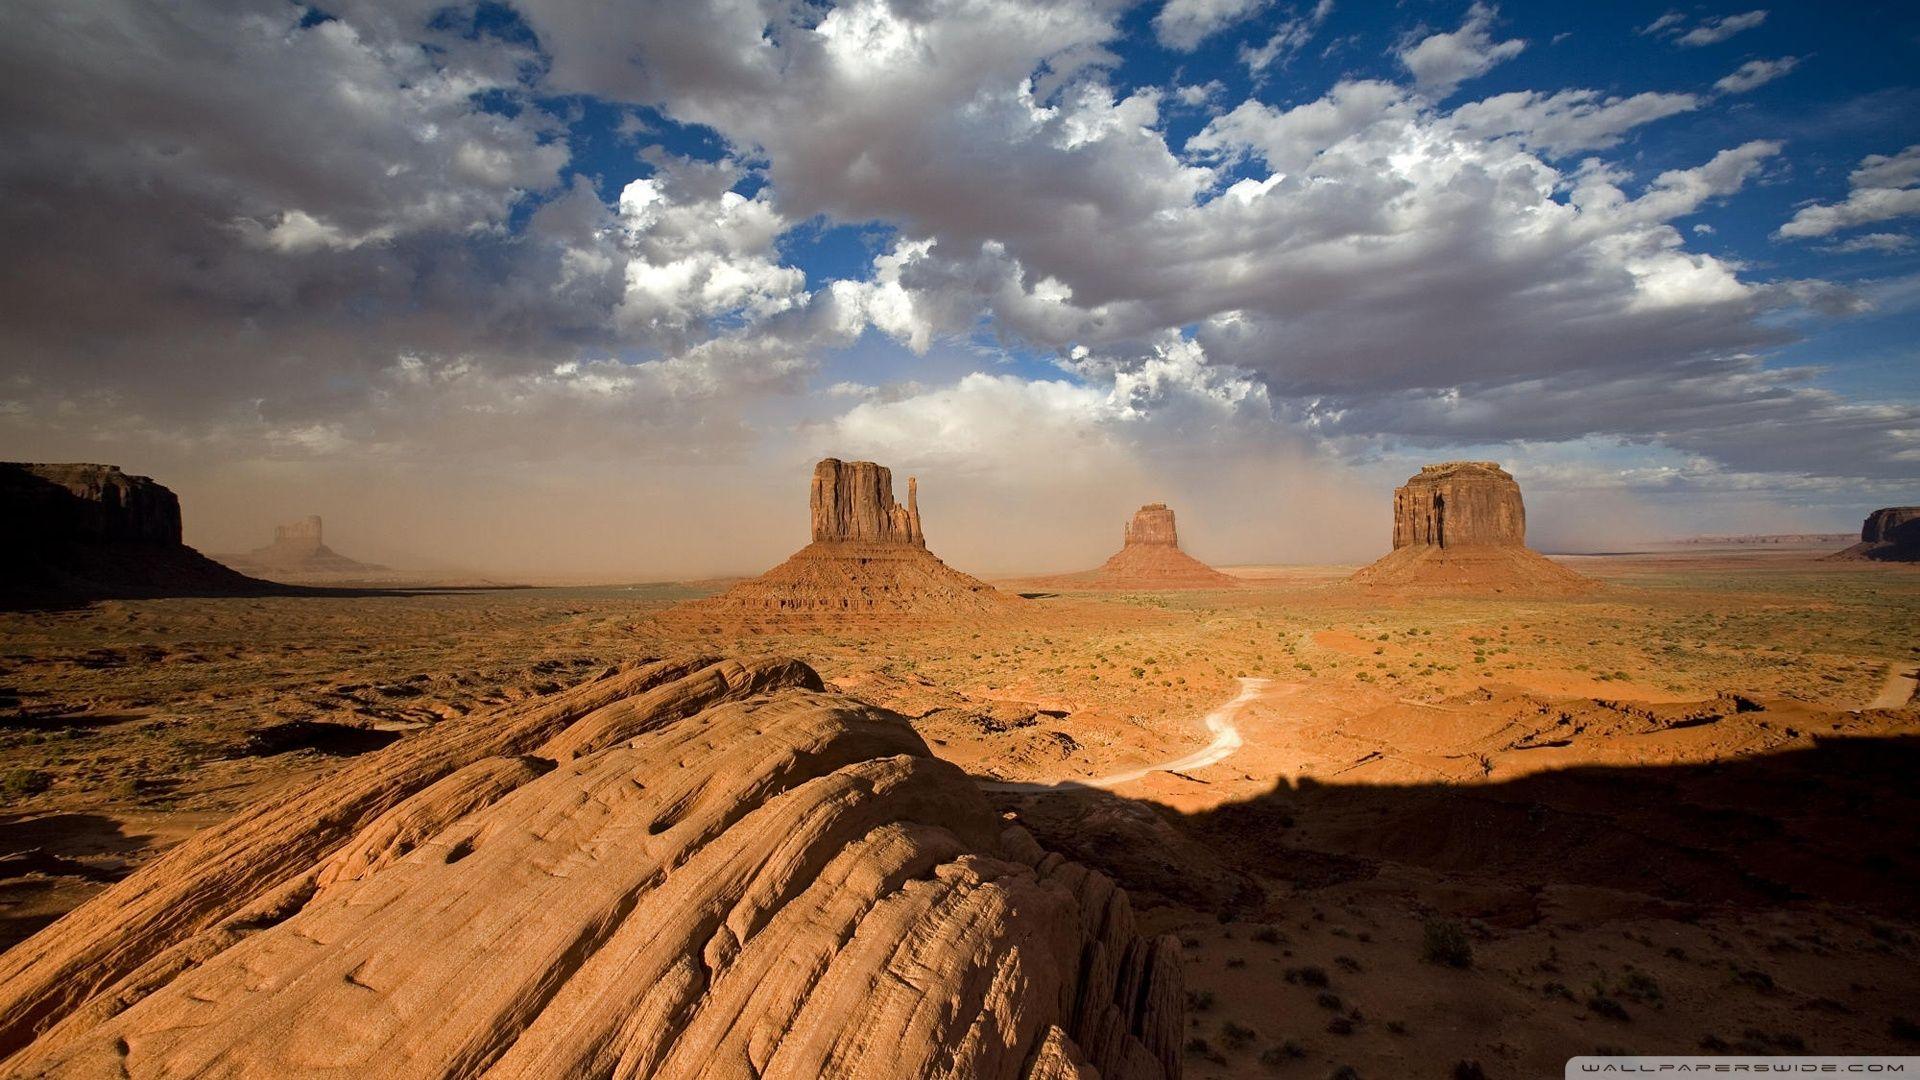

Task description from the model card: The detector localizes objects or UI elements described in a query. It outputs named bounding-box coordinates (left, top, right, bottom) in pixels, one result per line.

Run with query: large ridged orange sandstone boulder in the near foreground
left=0, top=657, right=1185, bottom=1080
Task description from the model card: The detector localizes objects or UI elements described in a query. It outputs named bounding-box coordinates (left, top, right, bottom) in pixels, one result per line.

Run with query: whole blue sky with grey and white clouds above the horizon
left=0, top=0, right=1920, bottom=580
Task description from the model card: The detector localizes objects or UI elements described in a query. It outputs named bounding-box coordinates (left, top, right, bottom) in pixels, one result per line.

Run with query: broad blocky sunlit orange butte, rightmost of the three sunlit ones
left=1354, top=461, right=1596, bottom=594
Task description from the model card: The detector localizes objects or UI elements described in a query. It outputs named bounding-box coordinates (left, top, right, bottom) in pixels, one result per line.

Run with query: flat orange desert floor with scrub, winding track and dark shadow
left=0, top=550, right=1920, bottom=1078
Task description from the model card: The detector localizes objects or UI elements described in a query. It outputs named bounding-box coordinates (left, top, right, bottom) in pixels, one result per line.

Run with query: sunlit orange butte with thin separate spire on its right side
left=672, top=457, right=1021, bottom=621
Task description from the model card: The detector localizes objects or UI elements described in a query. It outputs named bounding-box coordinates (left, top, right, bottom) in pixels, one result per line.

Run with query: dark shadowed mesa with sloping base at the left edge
left=0, top=461, right=278, bottom=603
